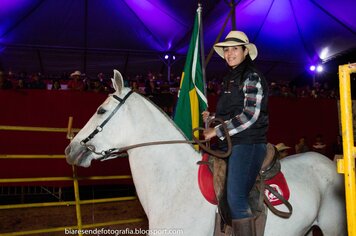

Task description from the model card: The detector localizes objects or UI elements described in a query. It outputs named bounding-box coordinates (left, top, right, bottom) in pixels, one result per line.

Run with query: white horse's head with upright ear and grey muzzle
left=65, top=70, right=136, bottom=167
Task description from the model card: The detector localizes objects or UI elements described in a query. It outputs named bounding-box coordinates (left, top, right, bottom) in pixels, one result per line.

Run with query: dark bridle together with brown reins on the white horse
left=80, top=90, right=232, bottom=161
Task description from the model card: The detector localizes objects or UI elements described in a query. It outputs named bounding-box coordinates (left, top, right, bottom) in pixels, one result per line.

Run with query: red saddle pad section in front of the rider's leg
left=198, top=153, right=218, bottom=205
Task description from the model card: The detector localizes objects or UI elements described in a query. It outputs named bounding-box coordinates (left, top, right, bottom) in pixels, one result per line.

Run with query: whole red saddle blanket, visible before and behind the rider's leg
left=198, top=153, right=290, bottom=206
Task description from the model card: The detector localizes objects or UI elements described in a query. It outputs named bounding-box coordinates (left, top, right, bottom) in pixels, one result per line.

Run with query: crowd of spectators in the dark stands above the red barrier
left=0, top=70, right=339, bottom=99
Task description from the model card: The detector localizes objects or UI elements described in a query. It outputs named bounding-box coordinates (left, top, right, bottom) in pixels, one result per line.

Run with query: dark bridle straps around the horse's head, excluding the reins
left=80, top=90, right=133, bottom=160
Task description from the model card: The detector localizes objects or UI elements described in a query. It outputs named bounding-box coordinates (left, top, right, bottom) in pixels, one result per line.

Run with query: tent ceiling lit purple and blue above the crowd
left=0, top=0, right=356, bottom=80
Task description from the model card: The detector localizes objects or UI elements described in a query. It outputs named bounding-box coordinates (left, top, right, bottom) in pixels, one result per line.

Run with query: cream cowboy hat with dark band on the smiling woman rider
left=214, top=30, right=257, bottom=60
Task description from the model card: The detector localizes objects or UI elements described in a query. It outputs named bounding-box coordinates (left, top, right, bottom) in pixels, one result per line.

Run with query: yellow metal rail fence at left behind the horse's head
left=0, top=117, right=144, bottom=236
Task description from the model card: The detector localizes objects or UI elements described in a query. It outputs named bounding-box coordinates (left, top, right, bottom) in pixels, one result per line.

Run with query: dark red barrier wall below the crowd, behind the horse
left=0, top=90, right=339, bottom=184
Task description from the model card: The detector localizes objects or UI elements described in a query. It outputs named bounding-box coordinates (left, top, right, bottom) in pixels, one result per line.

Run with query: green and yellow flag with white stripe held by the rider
left=174, top=7, right=208, bottom=140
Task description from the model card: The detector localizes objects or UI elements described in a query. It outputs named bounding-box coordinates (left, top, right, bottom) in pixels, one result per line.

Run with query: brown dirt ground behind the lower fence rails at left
left=0, top=200, right=148, bottom=236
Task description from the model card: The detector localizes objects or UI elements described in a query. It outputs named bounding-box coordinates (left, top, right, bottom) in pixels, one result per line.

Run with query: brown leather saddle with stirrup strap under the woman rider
left=198, top=143, right=292, bottom=236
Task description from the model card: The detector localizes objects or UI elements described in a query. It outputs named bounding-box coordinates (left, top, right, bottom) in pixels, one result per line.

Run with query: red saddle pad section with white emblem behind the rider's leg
left=265, top=172, right=290, bottom=206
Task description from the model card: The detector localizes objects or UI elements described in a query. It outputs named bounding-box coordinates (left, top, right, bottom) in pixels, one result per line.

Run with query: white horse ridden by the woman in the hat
left=65, top=71, right=346, bottom=236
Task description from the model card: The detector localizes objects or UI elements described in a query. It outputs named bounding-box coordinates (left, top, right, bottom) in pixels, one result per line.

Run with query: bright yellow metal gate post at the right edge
left=337, top=63, right=356, bottom=236
